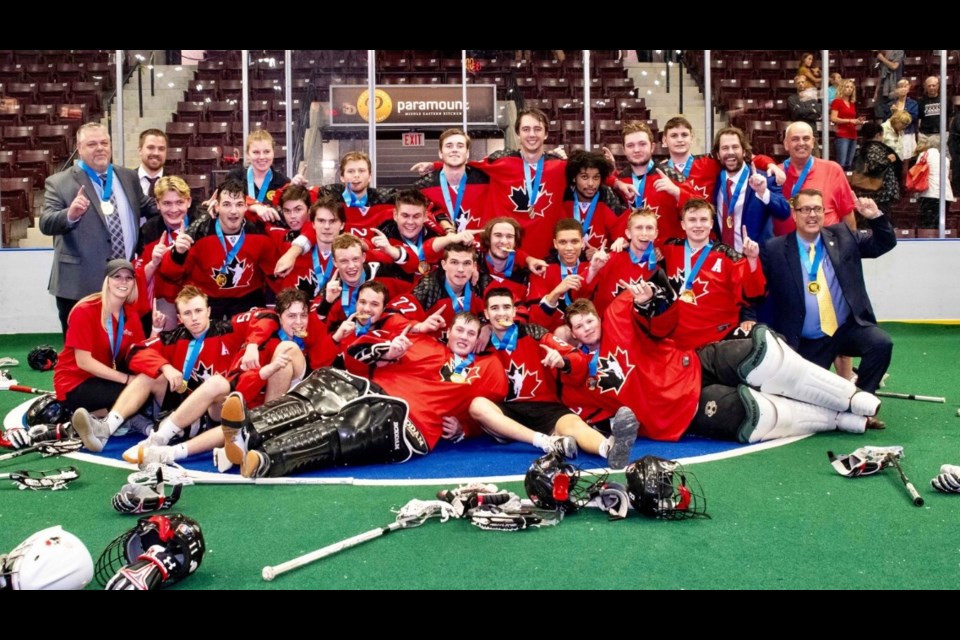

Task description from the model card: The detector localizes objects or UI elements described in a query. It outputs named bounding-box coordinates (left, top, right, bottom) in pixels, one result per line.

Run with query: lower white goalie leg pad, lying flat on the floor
left=737, top=385, right=867, bottom=443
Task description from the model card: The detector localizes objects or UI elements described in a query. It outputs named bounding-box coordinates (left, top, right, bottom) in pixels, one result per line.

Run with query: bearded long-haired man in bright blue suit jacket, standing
left=713, top=127, right=790, bottom=251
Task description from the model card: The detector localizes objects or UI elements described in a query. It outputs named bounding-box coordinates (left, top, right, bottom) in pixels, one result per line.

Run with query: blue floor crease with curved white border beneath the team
left=3, top=398, right=806, bottom=486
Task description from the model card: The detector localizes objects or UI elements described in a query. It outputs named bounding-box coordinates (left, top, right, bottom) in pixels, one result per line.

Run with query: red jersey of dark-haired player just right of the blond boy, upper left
left=159, top=218, right=279, bottom=299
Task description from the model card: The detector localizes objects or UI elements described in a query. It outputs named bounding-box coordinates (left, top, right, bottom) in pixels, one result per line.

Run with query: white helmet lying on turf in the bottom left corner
left=0, top=525, right=93, bottom=591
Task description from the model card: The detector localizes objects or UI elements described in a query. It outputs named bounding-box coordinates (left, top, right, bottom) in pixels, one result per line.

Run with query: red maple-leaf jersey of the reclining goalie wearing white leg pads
left=563, top=284, right=700, bottom=441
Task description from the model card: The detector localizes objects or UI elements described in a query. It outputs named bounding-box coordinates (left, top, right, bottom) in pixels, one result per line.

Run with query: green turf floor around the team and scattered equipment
left=0, top=324, right=960, bottom=589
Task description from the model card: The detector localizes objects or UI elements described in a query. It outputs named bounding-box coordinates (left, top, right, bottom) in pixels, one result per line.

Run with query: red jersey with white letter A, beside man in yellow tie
left=663, top=238, right=767, bottom=349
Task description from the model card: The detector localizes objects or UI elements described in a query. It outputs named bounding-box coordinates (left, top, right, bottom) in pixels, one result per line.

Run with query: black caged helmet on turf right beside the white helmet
left=96, top=513, right=206, bottom=586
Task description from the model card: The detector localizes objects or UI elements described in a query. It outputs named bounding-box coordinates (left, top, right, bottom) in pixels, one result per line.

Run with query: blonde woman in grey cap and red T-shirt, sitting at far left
left=53, top=259, right=149, bottom=412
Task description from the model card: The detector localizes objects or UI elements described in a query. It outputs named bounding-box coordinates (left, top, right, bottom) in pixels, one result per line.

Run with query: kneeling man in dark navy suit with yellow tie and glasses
left=760, top=189, right=897, bottom=393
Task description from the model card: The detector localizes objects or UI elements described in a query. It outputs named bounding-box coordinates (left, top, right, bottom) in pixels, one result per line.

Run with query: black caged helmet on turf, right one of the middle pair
left=625, top=456, right=707, bottom=520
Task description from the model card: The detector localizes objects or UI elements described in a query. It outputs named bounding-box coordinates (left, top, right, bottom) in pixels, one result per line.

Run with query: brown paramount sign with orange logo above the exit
left=330, top=84, right=497, bottom=128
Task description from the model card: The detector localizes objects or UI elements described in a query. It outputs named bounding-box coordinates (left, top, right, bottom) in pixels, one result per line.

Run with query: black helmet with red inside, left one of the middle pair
left=523, top=452, right=607, bottom=513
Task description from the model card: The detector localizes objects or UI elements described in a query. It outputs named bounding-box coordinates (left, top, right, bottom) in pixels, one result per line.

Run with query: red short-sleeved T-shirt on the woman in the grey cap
left=53, top=296, right=144, bottom=400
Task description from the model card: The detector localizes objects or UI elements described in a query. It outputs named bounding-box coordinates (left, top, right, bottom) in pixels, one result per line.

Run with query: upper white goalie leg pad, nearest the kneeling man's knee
left=739, top=325, right=880, bottom=416
